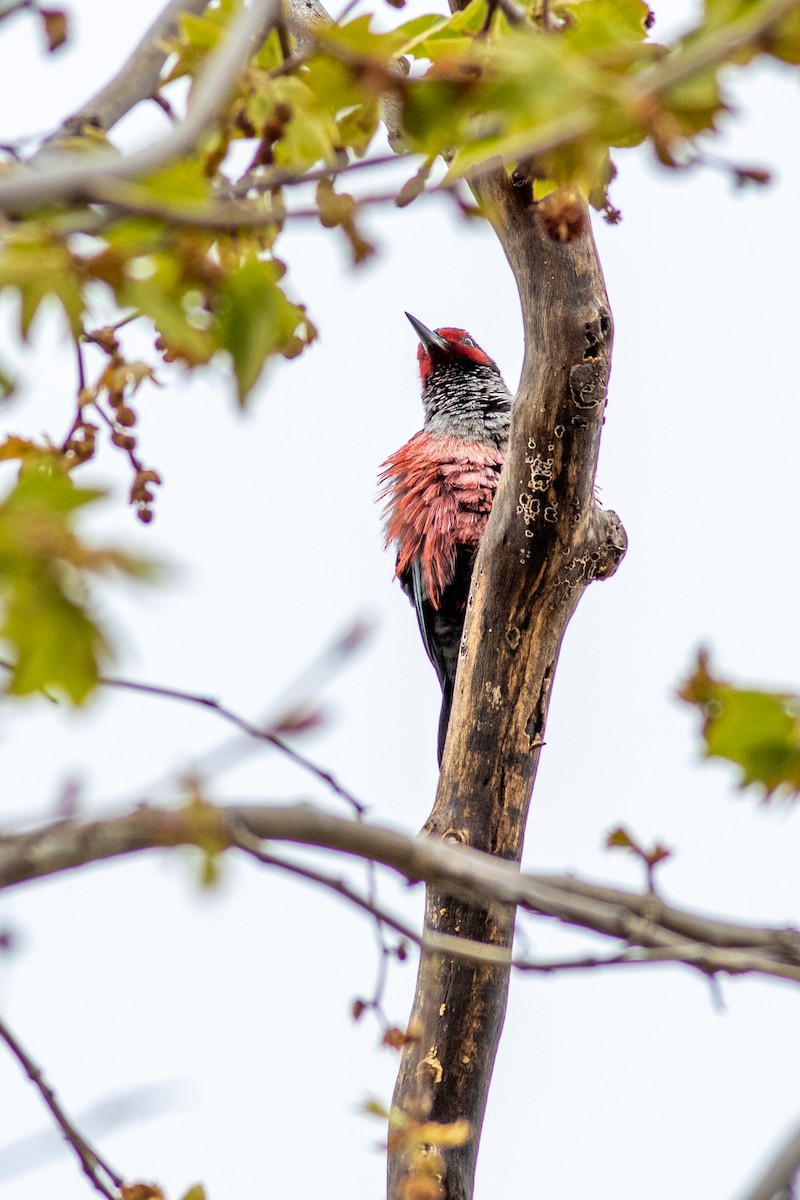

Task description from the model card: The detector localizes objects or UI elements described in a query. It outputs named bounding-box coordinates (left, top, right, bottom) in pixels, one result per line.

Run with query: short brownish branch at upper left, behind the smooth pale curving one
left=47, top=0, right=209, bottom=143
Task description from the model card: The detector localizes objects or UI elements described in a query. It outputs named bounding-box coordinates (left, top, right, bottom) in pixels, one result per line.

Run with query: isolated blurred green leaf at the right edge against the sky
left=679, top=653, right=800, bottom=799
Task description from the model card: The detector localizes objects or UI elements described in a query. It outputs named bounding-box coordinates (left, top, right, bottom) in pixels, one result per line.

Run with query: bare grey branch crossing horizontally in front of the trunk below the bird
left=0, top=804, right=800, bottom=983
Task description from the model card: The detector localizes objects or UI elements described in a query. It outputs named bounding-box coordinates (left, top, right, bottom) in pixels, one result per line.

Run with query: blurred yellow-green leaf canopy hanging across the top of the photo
left=0, top=0, right=800, bottom=404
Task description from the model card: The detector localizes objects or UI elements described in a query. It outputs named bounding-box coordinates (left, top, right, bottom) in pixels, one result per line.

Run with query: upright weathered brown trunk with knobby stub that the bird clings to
left=389, top=170, right=626, bottom=1200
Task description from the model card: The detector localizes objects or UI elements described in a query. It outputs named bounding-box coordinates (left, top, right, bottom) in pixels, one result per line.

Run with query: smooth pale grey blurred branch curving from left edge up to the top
left=0, top=0, right=281, bottom=210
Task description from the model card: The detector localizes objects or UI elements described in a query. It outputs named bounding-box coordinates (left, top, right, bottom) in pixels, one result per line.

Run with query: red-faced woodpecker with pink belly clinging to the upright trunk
left=379, top=312, right=511, bottom=766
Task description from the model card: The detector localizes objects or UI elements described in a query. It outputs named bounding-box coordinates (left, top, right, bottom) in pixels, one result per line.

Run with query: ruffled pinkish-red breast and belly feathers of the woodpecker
left=380, top=431, right=503, bottom=608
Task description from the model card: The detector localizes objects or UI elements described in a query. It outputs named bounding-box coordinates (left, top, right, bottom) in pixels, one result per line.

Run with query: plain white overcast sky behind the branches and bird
left=0, top=0, right=800, bottom=1200
